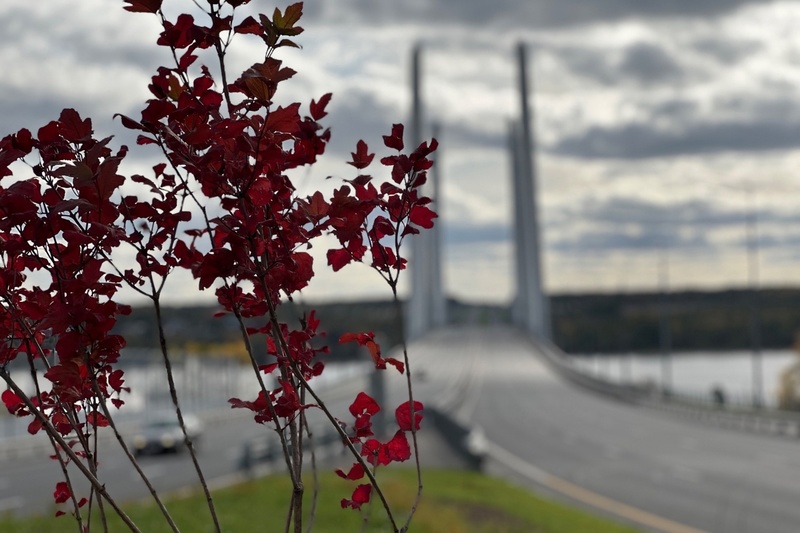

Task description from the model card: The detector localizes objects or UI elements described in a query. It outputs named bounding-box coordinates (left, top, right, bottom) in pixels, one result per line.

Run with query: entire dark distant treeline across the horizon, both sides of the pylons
left=111, top=289, right=800, bottom=359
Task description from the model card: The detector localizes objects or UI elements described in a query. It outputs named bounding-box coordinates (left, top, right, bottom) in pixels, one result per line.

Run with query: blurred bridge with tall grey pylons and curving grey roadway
left=398, top=45, right=800, bottom=533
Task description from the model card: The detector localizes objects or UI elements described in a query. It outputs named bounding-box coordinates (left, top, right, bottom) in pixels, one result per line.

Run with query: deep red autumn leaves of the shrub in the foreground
left=0, top=0, right=436, bottom=529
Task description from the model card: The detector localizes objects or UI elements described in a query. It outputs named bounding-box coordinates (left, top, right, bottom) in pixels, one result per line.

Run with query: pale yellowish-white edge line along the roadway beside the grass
left=489, top=443, right=706, bottom=533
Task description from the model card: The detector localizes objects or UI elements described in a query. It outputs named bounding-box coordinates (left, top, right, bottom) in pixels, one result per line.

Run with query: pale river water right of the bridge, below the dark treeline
left=572, top=350, right=800, bottom=406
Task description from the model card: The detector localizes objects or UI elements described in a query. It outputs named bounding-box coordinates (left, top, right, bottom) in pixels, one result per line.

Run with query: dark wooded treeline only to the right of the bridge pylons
left=551, top=288, right=800, bottom=353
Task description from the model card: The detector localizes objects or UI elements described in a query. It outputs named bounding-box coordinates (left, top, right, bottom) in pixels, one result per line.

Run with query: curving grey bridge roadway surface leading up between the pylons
left=411, top=327, right=800, bottom=533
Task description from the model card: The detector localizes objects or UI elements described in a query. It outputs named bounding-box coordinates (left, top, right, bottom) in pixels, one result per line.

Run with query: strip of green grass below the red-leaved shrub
left=0, top=469, right=634, bottom=533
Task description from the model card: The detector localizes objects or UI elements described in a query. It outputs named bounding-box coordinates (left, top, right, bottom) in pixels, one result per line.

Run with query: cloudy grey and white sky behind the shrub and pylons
left=0, top=0, right=800, bottom=303
